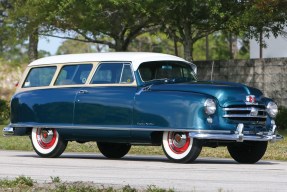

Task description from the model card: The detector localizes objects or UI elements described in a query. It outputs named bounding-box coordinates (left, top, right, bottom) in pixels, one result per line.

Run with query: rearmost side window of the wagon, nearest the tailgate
left=22, top=66, right=57, bottom=88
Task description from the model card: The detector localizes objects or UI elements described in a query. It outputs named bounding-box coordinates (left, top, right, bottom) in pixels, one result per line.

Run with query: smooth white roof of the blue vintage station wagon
left=28, top=52, right=188, bottom=71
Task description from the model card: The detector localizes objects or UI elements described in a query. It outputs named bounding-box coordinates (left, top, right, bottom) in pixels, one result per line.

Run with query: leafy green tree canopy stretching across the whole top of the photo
left=0, top=0, right=287, bottom=60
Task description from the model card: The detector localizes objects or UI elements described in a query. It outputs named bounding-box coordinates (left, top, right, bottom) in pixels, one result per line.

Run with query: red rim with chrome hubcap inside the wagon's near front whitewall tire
left=168, top=132, right=190, bottom=154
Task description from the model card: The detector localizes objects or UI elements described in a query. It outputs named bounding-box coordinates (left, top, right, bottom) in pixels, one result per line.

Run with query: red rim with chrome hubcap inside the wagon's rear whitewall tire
left=36, top=129, right=57, bottom=149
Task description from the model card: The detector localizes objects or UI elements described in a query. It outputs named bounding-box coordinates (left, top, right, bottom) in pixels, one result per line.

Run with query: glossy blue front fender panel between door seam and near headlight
left=133, top=91, right=215, bottom=129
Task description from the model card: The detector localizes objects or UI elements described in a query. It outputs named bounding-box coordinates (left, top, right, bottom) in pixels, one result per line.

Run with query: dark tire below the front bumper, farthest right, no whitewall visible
left=227, top=141, right=268, bottom=164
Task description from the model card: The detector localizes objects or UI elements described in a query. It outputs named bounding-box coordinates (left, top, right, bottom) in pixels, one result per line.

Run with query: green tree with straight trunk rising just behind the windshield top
left=162, top=0, right=237, bottom=60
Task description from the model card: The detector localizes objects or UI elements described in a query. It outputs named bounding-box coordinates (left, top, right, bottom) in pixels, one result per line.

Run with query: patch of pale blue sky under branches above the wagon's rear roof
left=38, top=37, right=65, bottom=55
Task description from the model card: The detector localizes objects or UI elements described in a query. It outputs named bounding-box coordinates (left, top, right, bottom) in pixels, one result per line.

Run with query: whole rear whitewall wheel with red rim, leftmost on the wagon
left=31, top=128, right=68, bottom=157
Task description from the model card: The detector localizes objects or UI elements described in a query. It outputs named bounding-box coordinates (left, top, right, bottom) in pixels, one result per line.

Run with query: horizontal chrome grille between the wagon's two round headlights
left=223, top=105, right=267, bottom=124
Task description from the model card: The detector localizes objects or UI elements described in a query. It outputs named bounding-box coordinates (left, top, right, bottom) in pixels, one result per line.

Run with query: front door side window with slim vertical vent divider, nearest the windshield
left=92, top=63, right=134, bottom=84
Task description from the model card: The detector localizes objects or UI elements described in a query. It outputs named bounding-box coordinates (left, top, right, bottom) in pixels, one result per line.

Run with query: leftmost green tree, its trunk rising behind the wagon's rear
left=5, top=0, right=56, bottom=61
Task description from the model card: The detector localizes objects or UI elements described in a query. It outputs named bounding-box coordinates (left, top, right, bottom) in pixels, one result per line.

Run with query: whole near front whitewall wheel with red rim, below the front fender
left=162, top=131, right=202, bottom=163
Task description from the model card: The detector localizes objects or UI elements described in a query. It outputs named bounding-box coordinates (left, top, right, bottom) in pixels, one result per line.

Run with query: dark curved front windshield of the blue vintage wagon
left=138, top=61, right=196, bottom=83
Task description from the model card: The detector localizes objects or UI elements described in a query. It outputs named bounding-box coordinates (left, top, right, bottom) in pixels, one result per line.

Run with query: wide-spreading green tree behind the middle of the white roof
left=42, top=0, right=161, bottom=51
